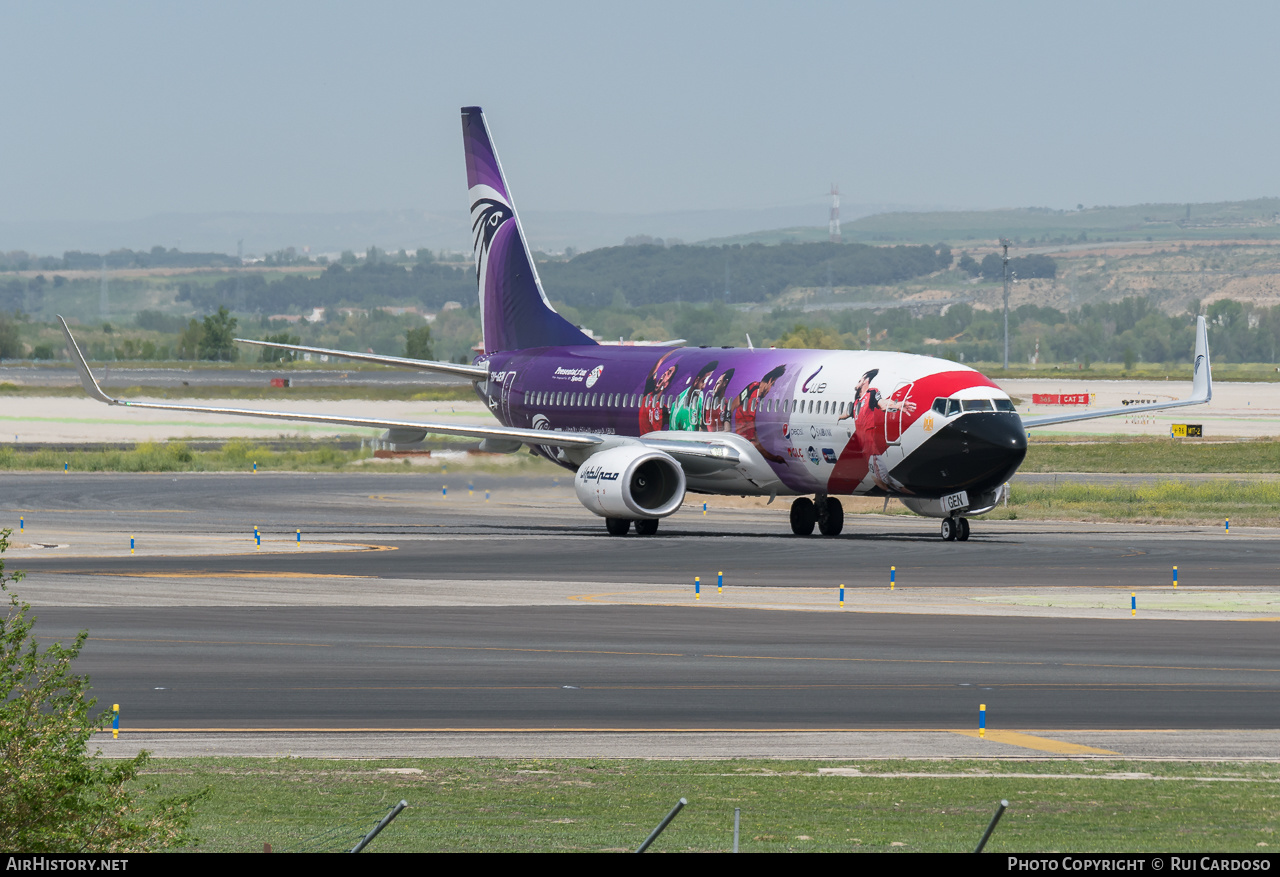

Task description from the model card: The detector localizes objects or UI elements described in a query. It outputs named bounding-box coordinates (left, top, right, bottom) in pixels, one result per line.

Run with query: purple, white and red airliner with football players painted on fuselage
left=58, top=106, right=1212, bottom=542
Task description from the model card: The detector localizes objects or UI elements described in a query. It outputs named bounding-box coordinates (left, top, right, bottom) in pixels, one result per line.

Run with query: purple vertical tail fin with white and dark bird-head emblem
left=462, top=106, right=595, bottom=353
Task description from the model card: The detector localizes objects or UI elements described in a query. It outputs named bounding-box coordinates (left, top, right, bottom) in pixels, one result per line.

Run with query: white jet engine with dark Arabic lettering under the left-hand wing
left=573, top=446, right=685, bottom=520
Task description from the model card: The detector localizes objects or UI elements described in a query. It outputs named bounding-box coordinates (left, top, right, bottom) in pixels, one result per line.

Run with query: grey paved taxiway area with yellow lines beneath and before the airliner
left=0, top=472, right=1280, bottom=757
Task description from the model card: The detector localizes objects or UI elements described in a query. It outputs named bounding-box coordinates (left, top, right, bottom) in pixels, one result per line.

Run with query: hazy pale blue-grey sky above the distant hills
left=0, top=0, right=1280, bottom=220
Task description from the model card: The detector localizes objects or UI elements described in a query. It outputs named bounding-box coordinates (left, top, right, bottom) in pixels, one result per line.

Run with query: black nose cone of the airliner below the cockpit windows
left=892, top=411, right=1027, bottom=495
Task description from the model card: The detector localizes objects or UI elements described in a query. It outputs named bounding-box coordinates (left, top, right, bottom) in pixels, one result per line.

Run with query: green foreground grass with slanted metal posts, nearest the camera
left=129, top=758, right=1280, bottom=853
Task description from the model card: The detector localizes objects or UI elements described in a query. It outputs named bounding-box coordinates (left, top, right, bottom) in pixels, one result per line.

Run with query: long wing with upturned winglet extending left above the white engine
left=58, top=316, right=604, bottom=447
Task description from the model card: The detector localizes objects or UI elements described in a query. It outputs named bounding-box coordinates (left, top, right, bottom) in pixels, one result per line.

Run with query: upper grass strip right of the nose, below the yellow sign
left=1019, top=435, right=1280, bottom=475
